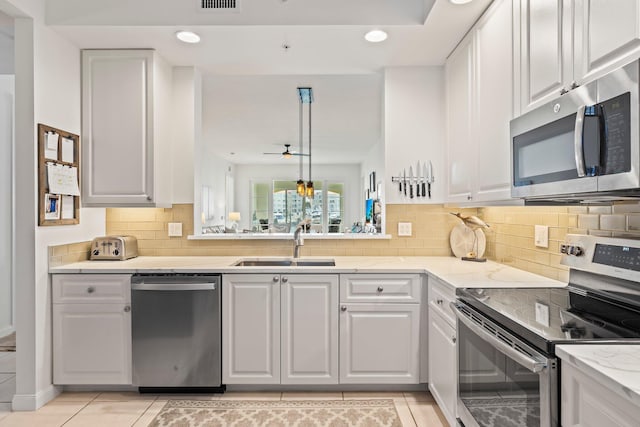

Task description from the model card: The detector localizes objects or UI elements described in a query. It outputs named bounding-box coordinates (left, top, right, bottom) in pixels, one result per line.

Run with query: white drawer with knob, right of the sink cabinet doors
left=340, top=274, right=422, bottom=303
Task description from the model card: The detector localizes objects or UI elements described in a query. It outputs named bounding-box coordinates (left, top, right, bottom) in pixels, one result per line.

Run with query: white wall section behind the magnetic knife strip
left=384, top=67, right=446, bottom=204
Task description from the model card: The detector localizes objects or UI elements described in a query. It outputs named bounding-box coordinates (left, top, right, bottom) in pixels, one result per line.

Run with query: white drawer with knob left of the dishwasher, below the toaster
left=52, top=274, right=131, bottom=304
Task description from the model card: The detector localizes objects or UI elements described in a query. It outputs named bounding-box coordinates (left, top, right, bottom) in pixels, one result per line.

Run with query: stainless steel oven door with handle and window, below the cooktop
left=453, top=302, right=558, bottom=427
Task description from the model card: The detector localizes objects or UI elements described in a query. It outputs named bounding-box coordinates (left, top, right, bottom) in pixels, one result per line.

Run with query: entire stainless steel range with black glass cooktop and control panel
left=452, top=235, right=640, bottom=427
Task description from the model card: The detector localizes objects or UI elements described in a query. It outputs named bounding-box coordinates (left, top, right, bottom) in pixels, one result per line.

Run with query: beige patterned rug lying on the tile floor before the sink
left=149, top=399, right=402, bottom=427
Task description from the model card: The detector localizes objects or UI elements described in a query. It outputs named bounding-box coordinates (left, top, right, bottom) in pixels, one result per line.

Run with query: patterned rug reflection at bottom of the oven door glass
left=463, top=397, right=540, bottom=427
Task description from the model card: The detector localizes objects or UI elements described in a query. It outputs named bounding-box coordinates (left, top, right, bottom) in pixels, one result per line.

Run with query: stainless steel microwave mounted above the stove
left=510, top=61, right=640, bottom=202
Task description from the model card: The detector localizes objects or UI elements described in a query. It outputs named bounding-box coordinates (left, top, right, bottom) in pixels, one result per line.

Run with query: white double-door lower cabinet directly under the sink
left=222, top=274, right=338, bottom=384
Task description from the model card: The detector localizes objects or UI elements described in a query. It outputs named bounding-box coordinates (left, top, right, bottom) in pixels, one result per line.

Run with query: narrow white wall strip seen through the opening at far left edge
left=0, top=76, right=14, bottom=337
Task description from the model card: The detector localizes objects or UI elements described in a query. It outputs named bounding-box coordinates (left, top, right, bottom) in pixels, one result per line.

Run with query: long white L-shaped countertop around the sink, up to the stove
left=49, top=256, right=566, bottom=288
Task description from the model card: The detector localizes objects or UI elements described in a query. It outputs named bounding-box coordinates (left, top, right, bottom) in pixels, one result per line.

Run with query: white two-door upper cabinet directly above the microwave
left=514, top=0, right=640, bottom=113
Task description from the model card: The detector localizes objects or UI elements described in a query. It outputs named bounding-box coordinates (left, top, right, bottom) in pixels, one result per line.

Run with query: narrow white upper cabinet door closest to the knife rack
left=445, top=37, right=476, bottom=202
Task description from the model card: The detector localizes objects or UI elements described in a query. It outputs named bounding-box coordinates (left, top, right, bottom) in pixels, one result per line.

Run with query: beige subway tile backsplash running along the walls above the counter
left=49, top=203, right=640, bottom=281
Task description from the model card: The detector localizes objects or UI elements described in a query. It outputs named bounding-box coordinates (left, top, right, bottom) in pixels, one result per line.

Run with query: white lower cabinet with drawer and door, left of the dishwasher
left=52, top=274, right=131, bottom=384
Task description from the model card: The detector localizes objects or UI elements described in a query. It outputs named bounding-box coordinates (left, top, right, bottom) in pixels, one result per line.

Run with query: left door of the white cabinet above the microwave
left=520, top=0, right=573, bottom=113
